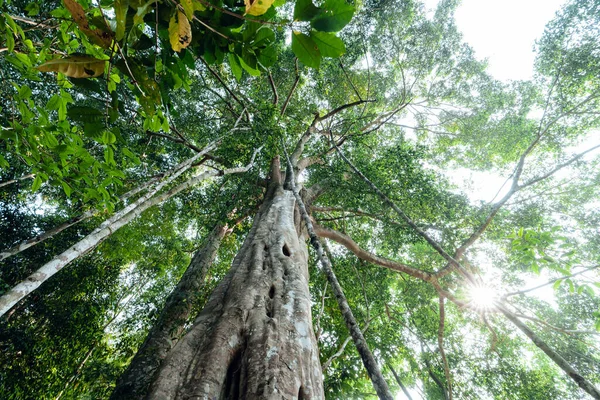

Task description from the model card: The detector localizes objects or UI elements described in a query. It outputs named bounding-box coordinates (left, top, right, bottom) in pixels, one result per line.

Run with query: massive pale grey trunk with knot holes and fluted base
left=148, top=159, right=324, bottom=400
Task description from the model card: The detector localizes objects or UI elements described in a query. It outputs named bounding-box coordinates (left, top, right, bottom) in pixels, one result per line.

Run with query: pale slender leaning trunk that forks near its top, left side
left=0, top=147, right=260, bottom=317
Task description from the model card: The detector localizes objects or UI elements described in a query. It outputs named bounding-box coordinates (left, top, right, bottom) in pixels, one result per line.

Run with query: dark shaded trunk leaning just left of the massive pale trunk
left=111, top=225, right=227, bottom=399
